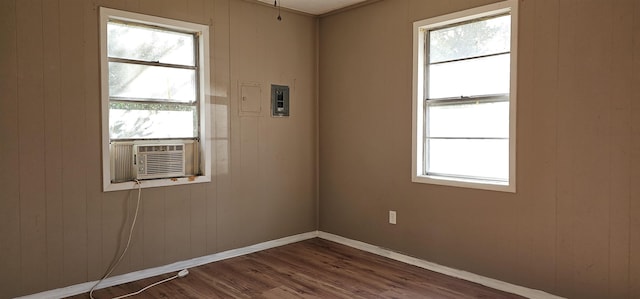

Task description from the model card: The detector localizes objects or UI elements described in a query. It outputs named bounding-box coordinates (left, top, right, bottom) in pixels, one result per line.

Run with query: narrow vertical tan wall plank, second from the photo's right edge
left=607, top=1, right=634, bottom=298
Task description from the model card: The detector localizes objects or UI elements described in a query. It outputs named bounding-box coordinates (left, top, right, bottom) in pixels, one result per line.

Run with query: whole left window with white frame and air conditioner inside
left=100, top=8, right=211, bottom=191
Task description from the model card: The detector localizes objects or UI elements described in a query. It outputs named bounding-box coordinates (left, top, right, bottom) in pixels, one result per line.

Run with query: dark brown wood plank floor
left=69, top=238, right=523, bottom=299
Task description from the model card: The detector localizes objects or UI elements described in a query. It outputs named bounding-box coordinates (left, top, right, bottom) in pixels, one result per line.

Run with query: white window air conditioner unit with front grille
left=133, top=144, right=185, bottom=179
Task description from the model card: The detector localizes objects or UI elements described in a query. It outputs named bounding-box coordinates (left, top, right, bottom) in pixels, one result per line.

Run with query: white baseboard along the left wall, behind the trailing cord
left=18, top=231, right=318, bottom=299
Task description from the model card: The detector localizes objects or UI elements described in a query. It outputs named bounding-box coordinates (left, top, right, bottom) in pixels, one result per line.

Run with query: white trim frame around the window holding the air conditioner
left=100, top=7, right=212, bottom=192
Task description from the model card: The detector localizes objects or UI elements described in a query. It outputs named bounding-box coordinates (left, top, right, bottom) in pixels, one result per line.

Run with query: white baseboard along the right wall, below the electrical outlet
left=318, top=231, right=564, bottom=299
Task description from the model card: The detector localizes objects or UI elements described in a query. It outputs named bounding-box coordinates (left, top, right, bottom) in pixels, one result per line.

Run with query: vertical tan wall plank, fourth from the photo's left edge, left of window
left=60, top=0, right=89, bottom=284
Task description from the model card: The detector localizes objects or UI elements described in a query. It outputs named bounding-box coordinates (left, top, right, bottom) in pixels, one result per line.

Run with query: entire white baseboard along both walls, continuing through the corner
left=18, top=231, right=563, bottom=299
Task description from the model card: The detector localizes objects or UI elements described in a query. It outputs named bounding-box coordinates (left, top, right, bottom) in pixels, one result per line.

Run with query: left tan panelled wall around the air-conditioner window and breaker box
left=0, top=0, right=317, bottom=298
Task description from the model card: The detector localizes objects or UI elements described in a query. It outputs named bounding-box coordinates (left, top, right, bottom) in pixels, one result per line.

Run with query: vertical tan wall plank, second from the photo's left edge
left=16, top=0, right=47, bottom=293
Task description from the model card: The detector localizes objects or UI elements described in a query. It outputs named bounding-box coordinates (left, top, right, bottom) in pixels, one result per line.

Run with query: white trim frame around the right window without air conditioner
left=411, top=0, right=518, bottom=193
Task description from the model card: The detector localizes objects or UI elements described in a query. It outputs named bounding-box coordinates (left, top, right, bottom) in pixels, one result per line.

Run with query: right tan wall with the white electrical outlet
left=319, top=0, right=640, bottom=298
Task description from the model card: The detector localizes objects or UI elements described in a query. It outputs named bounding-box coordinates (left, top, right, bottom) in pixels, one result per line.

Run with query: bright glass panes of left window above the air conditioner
left=107, top=20, right=199, bottom=140
